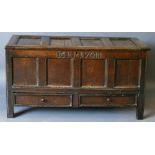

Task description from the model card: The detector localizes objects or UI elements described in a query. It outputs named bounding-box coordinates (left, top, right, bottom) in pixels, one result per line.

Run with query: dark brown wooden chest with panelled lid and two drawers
left=6, top=36, right=150, bottom=119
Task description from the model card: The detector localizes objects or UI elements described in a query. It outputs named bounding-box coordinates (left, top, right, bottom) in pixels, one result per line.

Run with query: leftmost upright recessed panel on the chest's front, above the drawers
left=13, top=58, right=37, bottom=86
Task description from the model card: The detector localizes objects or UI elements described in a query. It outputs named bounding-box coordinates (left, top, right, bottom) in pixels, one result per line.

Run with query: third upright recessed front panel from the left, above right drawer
left=81, top=60, right=105, bottom=87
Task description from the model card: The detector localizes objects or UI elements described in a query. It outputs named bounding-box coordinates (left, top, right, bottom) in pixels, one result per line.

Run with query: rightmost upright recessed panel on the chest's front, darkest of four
left=115, top=60, right=141, bottom=87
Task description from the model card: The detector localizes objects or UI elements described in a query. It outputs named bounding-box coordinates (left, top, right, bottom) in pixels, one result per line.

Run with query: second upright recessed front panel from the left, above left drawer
left=47, top=59, right=73, bottom=87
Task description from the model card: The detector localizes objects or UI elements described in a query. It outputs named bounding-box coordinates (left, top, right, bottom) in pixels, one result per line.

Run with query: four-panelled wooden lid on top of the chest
left=6, top=35, right=150, bottom=50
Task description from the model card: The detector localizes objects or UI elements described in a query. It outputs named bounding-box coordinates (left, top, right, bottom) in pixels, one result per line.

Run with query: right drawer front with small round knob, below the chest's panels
left=80, top=95, right=136, bottom=107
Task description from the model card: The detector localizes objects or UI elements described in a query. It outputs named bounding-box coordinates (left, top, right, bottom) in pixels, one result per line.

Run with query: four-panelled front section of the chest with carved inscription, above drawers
left=12, top=51, right=142, bottom=89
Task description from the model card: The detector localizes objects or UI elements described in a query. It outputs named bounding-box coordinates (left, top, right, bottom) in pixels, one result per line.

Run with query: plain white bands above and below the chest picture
left=0, top=0, right=155, bottom=155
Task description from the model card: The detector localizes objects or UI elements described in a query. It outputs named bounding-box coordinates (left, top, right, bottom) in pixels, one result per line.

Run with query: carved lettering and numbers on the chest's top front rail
left=56, top=51, right=101, bottom=59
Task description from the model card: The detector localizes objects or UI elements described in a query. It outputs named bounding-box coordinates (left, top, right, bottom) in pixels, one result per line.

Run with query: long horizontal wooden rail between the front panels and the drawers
left=12, top=86, right=139, bottom=95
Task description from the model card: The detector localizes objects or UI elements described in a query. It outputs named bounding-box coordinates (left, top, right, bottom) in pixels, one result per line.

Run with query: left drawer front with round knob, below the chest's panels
left=16, top=95, right=72, bottom=107
